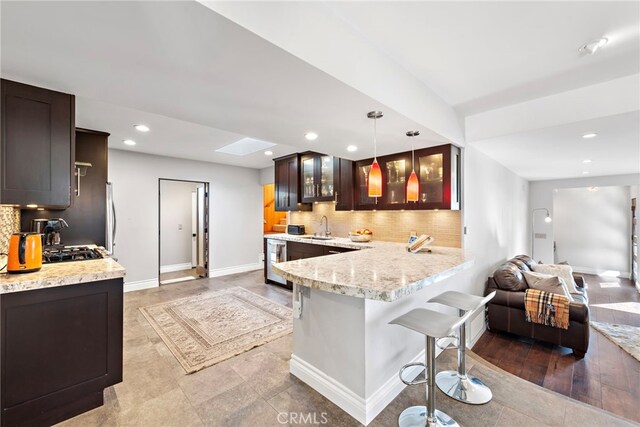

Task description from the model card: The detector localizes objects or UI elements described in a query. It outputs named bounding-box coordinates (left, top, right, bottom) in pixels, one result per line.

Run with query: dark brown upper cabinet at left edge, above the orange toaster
left=0, top=79, right=75, bottom=208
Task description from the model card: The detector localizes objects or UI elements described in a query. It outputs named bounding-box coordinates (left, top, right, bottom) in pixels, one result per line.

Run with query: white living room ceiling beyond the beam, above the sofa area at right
left=473, top=111, right=640, bottom=181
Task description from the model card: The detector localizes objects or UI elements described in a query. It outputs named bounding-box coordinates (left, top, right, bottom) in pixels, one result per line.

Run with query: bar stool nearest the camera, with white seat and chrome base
left=389, top=308, right=472, bottom=427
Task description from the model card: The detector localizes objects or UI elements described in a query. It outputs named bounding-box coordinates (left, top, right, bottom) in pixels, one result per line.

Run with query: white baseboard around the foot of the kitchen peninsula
left=289, top=340, right=451, bottom=426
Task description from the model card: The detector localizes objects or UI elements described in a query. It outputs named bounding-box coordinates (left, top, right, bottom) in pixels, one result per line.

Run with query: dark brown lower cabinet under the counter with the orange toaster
left=0, top=278, right=123, bottom=427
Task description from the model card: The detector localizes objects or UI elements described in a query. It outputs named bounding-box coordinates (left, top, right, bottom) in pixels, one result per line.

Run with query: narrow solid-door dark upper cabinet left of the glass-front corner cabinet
left=274, top=154, right=311, bottom=212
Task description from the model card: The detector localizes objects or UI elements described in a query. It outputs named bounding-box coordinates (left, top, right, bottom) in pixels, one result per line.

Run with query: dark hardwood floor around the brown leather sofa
left=473, top=275, right=640, bottom=422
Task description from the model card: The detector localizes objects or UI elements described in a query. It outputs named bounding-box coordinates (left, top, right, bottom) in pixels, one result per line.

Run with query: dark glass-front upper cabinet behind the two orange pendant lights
left=355, top=144, right=460, bottom=210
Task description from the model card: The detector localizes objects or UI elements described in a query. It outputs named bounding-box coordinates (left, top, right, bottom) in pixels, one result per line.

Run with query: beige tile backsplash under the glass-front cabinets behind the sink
left=289, top=203, right=462, bottom=248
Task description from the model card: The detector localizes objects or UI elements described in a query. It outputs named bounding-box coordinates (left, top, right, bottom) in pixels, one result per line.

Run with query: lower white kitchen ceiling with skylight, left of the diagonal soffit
left=1, top=2, right=447, bottom=168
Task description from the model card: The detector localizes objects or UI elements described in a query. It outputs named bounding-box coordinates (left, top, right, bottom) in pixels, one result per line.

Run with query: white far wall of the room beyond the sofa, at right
left=553, top=186, right=631, bottom=276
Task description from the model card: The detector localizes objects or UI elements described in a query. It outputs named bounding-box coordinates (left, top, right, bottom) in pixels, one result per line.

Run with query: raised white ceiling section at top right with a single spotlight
left=327, top=1, right=640, bottom=115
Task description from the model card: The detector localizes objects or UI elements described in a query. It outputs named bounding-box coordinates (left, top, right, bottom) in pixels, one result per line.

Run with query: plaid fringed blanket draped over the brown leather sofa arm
left=524, top=289, right=569, bottom=329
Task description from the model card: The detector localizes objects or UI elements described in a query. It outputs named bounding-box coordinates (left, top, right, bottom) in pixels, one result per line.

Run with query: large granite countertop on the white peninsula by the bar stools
left=269, top=235, right=474, bottom=302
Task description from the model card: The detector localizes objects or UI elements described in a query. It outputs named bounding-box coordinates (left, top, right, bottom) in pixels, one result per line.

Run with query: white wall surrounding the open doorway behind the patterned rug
left=109, top=150, right=262, bottom=289
